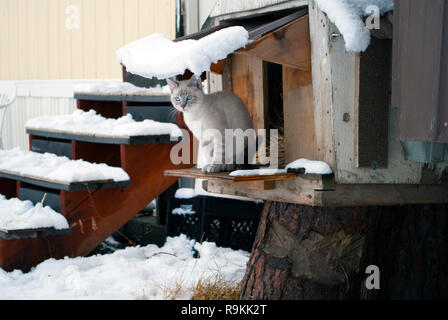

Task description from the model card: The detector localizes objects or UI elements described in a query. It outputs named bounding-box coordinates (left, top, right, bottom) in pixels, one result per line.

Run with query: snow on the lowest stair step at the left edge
left=0, top=194, right=69, bottom=231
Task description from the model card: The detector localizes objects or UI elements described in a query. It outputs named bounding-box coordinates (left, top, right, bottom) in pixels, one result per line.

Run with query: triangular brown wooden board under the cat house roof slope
left=235, top=15, right=311, bottom=71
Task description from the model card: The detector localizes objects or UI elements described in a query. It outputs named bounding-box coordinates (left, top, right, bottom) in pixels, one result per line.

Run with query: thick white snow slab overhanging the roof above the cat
left=117, top=26, right=249, bottom=79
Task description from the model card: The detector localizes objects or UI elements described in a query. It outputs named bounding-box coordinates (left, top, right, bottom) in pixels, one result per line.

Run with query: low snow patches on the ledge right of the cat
left=229, top=159, right=333, bottom=177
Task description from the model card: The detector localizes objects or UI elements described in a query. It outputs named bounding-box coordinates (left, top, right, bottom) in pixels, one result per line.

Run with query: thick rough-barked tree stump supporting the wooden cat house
left=240, top=202, right=448, bottom=300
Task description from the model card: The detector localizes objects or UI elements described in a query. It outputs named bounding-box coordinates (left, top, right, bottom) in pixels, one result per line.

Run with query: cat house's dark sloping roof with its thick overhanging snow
left=117, top=9, right=309, bottom=80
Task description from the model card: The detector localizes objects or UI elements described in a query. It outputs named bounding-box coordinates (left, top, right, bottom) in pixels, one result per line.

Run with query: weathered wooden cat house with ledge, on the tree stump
left=133, top=1, right=448, bottom=206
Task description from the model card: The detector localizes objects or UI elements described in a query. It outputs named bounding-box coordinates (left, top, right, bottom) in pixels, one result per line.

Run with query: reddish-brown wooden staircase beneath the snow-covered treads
left=0, top=91, right=191, bottom=271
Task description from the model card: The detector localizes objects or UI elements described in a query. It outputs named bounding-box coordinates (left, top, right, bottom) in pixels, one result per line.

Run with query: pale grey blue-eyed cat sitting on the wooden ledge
left=167, top=76, right=256, bottom=173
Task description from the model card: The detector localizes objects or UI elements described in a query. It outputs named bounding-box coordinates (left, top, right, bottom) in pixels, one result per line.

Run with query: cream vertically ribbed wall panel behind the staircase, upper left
left=0, top=0, right=176, bottom=80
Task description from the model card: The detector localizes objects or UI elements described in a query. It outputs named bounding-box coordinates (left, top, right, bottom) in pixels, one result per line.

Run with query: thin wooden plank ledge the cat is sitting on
left=165, top=169, right=296, bottom=182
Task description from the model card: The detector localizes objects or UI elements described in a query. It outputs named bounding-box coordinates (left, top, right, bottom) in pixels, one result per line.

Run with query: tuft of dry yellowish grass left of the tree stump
left=191, top=274, right=241, bottom=300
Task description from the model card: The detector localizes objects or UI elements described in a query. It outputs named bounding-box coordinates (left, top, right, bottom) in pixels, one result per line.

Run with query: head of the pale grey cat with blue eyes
left=167, top=77, right=203, bottom=112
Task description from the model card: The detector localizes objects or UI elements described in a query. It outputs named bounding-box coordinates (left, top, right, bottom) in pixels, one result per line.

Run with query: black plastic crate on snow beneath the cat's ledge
left=166, top=195, right=263, bottom=251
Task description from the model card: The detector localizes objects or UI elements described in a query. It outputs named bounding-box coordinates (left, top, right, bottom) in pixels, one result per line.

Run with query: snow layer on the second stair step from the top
left=25, top=109, right=182, bottom=138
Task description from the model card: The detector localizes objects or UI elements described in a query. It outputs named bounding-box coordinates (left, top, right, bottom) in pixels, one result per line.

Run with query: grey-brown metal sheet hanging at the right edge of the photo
left=393, top=0, right=448, bottom=142
